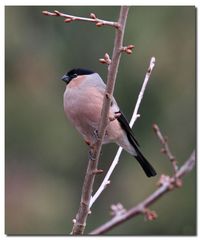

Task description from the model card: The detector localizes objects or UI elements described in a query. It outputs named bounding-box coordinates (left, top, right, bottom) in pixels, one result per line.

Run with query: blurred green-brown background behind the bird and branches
left=5, top=6, right=196, bottom=235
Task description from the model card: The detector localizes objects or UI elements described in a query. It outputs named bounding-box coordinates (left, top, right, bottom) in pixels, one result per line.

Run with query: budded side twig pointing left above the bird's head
left=42, top=10, right=120, bottom=29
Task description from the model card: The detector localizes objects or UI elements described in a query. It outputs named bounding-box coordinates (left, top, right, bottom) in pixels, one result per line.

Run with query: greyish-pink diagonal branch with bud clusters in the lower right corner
left=90, top=151, right=196, bottom=235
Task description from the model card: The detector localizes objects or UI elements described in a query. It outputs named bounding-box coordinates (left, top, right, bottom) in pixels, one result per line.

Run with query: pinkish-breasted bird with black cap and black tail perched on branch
left=61, top=68, right=156, bottom=177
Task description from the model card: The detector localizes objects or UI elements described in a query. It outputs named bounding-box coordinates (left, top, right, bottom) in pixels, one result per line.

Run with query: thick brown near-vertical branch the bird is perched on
left=72, top=7, right=129, bottom=235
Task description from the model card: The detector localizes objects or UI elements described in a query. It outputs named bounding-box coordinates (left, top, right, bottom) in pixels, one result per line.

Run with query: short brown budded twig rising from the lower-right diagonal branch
left=153, top=124, right=178, bottom=173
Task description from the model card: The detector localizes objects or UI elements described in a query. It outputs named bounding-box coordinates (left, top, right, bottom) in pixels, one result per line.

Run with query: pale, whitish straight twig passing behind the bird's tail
left=90, top=57, right=155, bottom=208
